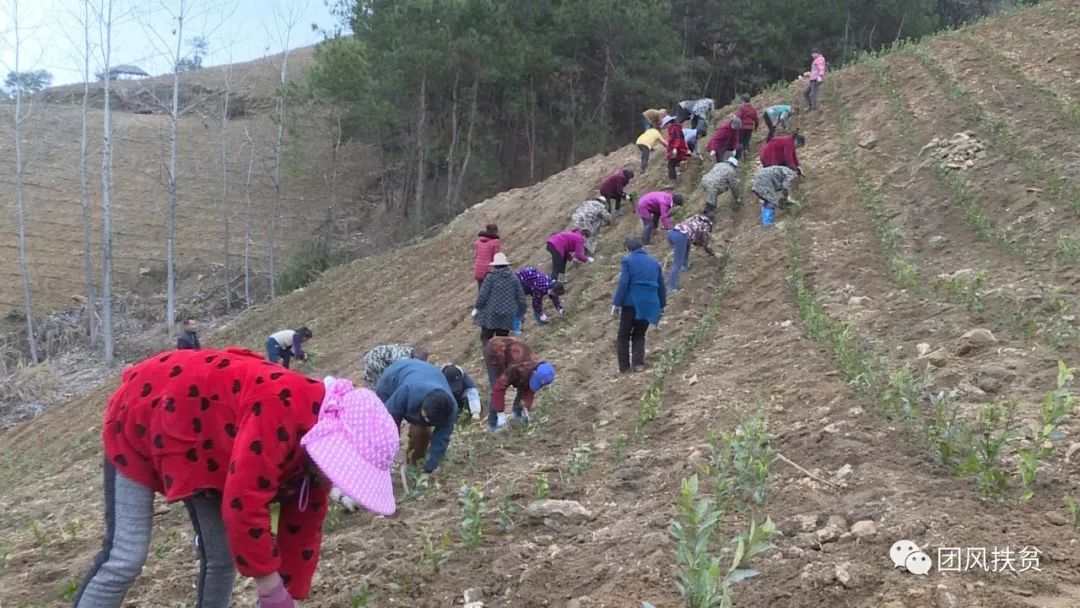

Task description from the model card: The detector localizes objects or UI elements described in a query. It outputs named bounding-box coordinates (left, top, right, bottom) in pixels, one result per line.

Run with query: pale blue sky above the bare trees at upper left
left=0, top=0, right=337, bottom=84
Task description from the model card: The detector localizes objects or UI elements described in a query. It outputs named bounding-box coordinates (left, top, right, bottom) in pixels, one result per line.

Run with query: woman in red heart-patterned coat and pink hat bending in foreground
left=75, top=349, right=399, bottom=608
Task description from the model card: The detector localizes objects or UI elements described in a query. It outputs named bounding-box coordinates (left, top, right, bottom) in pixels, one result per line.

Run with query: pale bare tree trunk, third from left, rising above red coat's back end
left=102, top=0, right=114, bottom=365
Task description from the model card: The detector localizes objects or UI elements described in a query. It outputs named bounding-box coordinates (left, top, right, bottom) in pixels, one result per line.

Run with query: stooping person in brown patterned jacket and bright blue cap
left=484, top=338, right=555, bottom=431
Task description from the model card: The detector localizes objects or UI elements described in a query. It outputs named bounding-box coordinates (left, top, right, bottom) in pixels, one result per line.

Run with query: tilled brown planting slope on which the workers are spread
left=0, top=2, right=1080, bottom=608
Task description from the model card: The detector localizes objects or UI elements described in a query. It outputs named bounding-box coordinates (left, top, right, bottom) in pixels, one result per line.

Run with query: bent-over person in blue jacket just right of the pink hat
left=375, top=359, right=458, bottom=473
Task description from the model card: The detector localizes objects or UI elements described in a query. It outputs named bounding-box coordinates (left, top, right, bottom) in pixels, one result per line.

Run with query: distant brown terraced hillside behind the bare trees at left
left=0, top=48, right=378, bottom=314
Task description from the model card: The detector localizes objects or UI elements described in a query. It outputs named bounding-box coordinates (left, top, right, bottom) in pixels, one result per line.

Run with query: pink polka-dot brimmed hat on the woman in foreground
left=300, top=379, right=401, bottom=515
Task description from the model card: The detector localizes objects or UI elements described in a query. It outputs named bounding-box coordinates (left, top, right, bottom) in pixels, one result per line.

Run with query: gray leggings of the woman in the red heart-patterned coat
left=75, top=459, right=237, bottom=608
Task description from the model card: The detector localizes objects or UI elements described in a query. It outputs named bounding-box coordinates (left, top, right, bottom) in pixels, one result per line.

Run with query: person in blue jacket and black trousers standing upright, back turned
left=611, top=237, right=667, bottom=374
